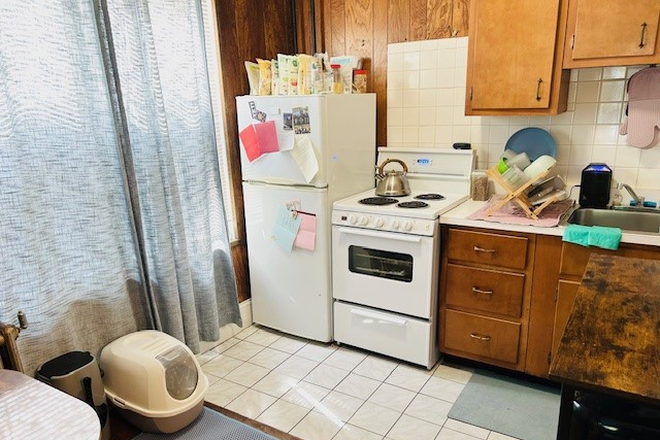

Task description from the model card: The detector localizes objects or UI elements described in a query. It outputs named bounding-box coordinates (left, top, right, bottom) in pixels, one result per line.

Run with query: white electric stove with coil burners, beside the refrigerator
left=332, top=147, right=475, bottom=368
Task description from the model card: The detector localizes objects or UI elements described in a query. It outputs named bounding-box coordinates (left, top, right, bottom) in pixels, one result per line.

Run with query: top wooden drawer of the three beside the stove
left=447, top=229, right=529, bottom=269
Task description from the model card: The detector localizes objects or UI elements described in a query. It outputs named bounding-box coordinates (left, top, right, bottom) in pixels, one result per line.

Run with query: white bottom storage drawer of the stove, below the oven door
left=334, top=301, right=438, bottom=368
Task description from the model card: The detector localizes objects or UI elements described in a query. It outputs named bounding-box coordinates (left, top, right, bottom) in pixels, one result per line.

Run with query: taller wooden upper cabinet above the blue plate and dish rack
left=465, top=0, right=569, bottom=115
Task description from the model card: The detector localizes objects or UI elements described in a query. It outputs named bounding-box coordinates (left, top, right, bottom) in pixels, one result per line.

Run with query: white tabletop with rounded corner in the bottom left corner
left=0, top=369, right=101, bottom=440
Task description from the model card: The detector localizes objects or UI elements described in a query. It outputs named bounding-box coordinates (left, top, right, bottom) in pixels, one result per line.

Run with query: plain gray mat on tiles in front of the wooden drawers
left=449, top=371, right=560, bottom=440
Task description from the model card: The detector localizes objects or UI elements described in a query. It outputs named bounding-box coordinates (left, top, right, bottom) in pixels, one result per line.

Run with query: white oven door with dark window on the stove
left=332, top=225, right=439, bottom=319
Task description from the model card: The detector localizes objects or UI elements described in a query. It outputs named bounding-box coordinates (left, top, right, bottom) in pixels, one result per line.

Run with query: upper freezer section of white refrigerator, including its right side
left=236, top=94, right=376, bottom=202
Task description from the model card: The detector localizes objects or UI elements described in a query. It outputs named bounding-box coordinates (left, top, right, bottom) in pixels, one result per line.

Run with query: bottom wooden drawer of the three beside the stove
left=444, top=310, right=520, bottom=364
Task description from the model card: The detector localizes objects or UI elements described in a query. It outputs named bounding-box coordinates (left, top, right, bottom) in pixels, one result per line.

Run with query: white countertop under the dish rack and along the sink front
left=440, top=200, right=660, bottom=246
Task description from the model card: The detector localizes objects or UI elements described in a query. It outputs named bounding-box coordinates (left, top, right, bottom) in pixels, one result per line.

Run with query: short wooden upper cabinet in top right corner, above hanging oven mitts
left=564, top=0, right=660, bottom=68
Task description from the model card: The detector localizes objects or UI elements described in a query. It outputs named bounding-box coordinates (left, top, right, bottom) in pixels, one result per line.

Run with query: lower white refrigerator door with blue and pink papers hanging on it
left=243, top=183, right=332, bottom=342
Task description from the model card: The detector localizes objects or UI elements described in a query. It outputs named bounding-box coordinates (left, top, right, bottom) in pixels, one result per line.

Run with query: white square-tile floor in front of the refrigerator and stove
left=198, top=325, right=516, bottom=440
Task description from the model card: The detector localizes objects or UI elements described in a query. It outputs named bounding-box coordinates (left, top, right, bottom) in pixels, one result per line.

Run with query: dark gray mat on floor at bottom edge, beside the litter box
left=133, top=408, right=277, bottom=440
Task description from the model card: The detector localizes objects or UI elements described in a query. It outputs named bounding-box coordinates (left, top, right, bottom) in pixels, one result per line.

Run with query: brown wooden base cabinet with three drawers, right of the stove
left=439, top=227, right=535, bottom=371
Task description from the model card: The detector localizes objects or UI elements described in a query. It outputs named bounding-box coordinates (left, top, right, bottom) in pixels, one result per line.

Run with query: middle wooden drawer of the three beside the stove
left=446, top=264, right=525, bottom=318
